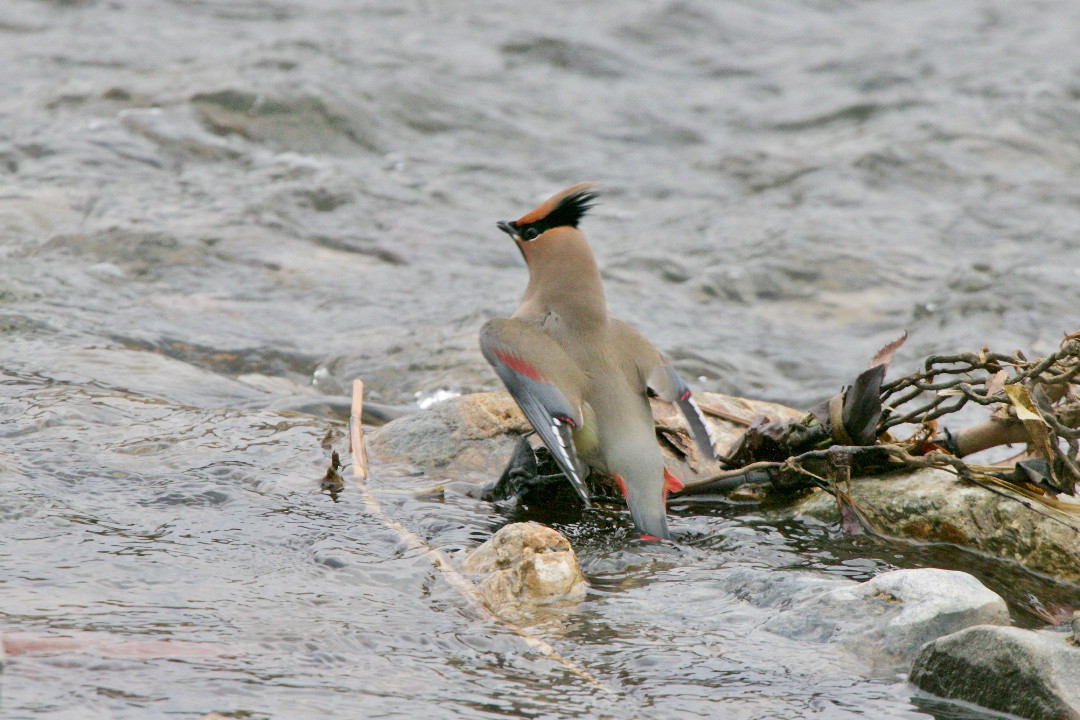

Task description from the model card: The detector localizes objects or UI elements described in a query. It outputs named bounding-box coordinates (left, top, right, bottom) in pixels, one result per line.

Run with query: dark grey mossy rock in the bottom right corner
left=910, top=625, right=1080, bottom=720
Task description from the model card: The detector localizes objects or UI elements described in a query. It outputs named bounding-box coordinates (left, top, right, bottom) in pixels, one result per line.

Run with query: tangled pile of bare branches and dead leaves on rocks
left=684, top=331, right=1080, bottom=500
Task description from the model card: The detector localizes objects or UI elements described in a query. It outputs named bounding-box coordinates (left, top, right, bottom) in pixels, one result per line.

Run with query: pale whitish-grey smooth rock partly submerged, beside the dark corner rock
left=725, top=568, right=1009, bottom=673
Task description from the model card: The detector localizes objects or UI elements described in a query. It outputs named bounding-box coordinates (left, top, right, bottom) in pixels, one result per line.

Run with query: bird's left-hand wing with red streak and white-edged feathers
left=480, top=318, right=589, bottom=506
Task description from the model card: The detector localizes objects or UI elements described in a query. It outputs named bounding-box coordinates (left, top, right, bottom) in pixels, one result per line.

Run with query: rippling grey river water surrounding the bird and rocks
left=0, top=0, right=1080, bottom=720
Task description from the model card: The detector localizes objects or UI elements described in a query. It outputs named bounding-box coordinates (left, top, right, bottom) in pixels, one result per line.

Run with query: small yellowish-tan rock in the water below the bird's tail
left=462, top=522, right=585, bottom=613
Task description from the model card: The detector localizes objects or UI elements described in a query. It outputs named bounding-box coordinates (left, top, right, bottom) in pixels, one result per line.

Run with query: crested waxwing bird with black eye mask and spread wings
left=480, top=182, right=716, bottom=538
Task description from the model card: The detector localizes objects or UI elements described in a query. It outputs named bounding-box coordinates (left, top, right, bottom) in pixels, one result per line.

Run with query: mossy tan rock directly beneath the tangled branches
left=794, top=470, right=1080, bottom=582
